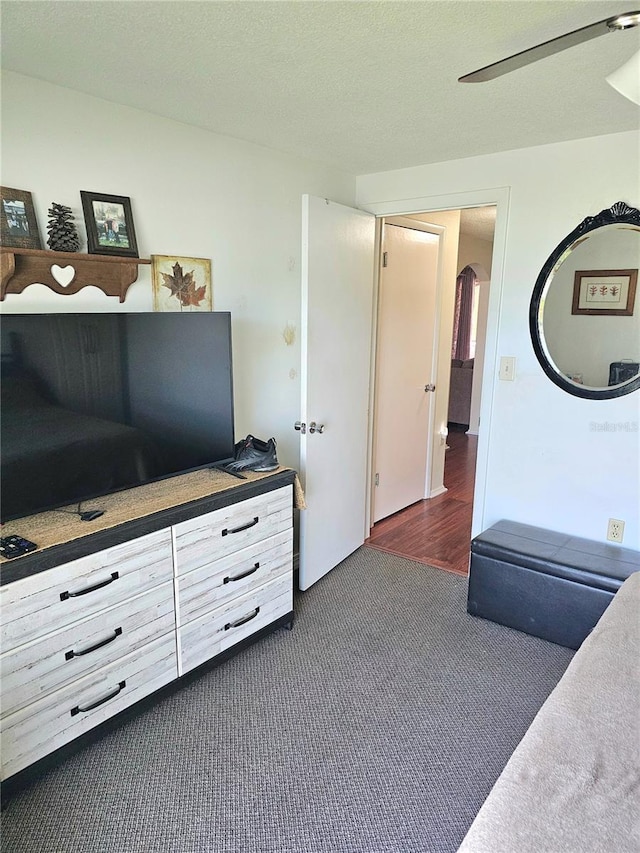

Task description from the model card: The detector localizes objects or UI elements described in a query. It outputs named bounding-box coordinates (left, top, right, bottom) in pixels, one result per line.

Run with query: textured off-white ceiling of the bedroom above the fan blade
left=2, top=0, right=640, bottom=174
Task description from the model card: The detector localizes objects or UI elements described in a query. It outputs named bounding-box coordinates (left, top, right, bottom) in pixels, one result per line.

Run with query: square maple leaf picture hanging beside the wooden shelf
left=151, top=255, right=213, bottom=311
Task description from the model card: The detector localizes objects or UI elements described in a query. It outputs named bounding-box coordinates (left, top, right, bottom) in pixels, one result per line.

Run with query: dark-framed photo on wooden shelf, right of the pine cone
left=80, top=190, right=138, bottom=258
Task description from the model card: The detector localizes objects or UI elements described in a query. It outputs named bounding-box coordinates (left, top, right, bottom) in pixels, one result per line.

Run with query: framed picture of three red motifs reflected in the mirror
left=571, top=270, right=638, bottom=317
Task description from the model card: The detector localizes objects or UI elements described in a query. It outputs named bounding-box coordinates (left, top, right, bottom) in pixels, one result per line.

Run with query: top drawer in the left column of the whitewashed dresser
left=0, top=529, right=173, bottom=652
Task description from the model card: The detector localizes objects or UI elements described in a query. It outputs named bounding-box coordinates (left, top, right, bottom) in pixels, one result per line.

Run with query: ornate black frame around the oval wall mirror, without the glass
left=529, top=201, right=640, bottom=400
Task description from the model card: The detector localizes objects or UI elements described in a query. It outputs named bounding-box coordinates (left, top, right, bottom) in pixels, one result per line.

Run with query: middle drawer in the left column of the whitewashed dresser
left=0, top=581, right=175, bottom=717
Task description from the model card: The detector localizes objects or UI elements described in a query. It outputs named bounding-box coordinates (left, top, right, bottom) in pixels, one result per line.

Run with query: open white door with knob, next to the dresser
left=296, top=195, right=375, bottom=590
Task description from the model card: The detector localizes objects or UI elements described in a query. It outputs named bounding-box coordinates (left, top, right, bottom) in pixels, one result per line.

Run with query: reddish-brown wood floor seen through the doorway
left=365, top=429, right=478, bottom=575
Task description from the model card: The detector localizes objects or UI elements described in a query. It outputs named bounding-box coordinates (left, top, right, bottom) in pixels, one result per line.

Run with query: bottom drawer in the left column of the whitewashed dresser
left=2, top=634, right=177, bottom=779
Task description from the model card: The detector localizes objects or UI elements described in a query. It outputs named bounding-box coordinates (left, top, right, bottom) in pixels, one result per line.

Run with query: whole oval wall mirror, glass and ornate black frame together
left=529, top=201, right=640, bottom=400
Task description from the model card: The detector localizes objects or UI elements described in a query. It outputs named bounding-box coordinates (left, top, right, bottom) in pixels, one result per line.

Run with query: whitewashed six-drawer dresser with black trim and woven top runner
left=0, top=469, right=299, bottom=793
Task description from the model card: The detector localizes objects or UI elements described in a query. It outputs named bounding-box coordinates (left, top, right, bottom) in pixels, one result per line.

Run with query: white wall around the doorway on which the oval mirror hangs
left=357, top=130, right=640, bottom=549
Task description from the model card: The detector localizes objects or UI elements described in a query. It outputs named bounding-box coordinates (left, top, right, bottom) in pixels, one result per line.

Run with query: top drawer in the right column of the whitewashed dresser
left=174, top=486, right=293, bottom=575
